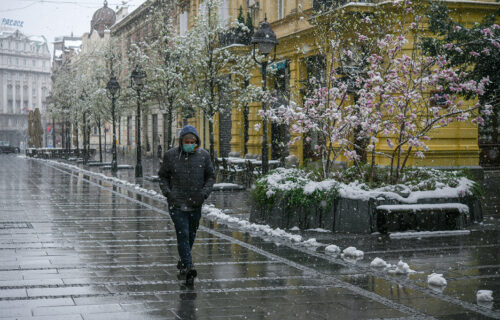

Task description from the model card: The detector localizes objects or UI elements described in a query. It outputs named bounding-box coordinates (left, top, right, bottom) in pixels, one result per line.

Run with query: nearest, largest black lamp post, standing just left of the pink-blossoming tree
left=252, top=18, right=278, bottom=174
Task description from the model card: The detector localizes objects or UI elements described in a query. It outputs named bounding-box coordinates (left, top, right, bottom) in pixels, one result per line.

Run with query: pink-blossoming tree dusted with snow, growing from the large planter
left=265, top=1, right=491, bottom=183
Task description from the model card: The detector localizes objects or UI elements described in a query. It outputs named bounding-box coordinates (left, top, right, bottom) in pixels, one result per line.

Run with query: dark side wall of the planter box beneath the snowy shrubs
left=250, top=191, right=483, bottom=234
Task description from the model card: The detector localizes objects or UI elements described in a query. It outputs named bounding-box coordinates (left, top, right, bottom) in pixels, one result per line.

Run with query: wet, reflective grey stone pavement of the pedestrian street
left=0, top=155, right=500, bottom=320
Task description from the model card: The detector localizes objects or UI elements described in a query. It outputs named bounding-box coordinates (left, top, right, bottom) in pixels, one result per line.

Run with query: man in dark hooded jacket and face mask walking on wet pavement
left=158, top=125, right=215, bottom=285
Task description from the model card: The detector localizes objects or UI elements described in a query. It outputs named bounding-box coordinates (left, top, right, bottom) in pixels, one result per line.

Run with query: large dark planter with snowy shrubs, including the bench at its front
left=250, top=168, right=482, bottom=233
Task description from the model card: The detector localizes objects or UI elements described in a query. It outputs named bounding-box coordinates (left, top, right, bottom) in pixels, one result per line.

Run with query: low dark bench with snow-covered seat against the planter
left=376, top=203, right=469, bottom=233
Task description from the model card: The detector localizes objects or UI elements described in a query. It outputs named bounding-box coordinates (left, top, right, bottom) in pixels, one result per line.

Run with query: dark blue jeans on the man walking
left=170, top=208, right=201, bottom=268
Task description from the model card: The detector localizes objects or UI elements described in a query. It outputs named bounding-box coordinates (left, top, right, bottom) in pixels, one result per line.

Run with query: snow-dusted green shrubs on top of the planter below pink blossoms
left=252, top=168, right=481, bottom=207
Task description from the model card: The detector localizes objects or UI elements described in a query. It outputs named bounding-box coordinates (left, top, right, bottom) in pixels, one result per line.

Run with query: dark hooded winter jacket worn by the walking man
left=158, top=125, right=215, bottom=210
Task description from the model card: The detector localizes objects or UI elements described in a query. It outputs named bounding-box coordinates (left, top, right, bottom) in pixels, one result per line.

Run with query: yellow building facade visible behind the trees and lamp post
left=178, top=0, right=499, bottom=166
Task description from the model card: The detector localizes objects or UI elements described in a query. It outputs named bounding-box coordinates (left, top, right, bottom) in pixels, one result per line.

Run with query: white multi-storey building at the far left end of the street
left=0, top=30, right=51, bottom=146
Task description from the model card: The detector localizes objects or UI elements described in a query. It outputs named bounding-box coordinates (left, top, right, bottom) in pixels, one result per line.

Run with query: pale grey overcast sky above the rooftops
left=0, top=0, right=145, bottom=52
